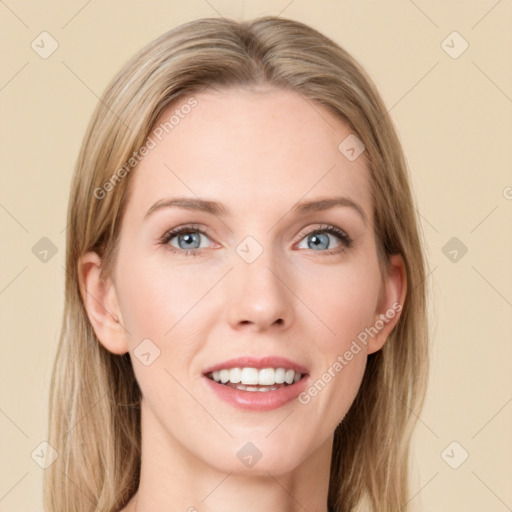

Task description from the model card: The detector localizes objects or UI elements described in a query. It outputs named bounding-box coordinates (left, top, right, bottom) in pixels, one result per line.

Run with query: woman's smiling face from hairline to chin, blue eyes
left=83, top=89, right=405, bottom=474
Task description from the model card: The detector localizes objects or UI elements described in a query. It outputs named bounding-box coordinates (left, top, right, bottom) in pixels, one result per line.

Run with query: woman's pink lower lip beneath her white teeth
left=203, top=376, right=307, bottom=411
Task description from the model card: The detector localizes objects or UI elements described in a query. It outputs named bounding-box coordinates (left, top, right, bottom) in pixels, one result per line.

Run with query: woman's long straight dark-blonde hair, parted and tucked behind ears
left=44, top=16, right=429, bottom=512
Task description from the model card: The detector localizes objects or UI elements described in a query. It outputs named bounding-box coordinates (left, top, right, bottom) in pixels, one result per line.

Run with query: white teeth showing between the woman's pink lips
left=211, top=368, right=302, bottom=391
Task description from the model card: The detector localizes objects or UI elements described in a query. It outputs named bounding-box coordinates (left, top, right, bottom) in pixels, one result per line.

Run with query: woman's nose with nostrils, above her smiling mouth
left=227, top=250, right=294, bottom=331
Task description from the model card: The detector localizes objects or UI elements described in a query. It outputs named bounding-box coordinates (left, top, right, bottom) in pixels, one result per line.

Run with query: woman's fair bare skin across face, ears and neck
left=80, top=88, right=406, bottom=512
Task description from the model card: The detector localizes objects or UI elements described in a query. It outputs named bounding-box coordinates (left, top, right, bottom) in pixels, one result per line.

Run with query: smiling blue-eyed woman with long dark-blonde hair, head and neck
left=45, top=17, right=428, bottom=512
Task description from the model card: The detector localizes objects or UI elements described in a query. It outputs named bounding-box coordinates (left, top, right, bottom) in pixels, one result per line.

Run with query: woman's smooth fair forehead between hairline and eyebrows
left=124, top=88, right=371, bottom=222
